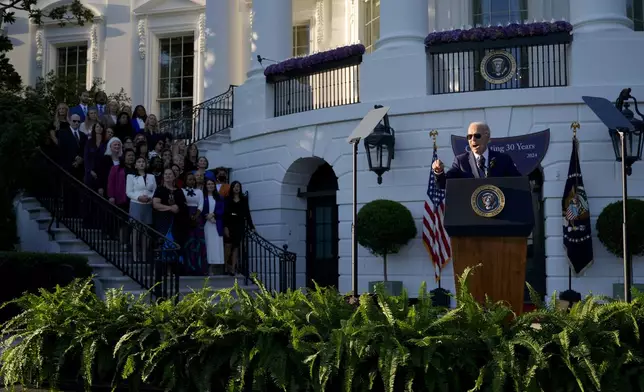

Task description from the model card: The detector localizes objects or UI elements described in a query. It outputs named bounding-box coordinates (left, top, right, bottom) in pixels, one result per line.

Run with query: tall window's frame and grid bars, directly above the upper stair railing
left=154, top=31, right=199, bottom=119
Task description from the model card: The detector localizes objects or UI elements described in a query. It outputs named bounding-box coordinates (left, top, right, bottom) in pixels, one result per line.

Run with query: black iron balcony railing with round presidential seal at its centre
left=427, top=33, right=572, bottom=94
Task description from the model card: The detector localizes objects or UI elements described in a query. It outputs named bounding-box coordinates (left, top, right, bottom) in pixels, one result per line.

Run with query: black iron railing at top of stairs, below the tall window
left=159, top=86, right=236, bottom=143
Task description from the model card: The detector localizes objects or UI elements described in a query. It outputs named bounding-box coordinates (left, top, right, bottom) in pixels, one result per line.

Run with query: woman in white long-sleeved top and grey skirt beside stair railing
left=125, top=157, right=157, bottom=261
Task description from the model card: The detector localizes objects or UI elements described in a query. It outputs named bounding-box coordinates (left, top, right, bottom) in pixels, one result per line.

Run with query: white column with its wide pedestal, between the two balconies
left=360, top=0, right=431, bottom=103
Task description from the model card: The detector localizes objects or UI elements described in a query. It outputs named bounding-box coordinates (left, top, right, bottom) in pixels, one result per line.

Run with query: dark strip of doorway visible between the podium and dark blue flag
left=524, top=167, right=546, bottom=302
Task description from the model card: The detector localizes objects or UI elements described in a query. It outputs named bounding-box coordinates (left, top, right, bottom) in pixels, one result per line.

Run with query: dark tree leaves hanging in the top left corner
left=0, top=0, right=94, bottom=92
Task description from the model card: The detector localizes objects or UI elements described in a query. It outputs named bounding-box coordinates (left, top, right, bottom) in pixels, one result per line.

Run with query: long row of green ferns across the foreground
left=0, top=271, right=644, bottom=392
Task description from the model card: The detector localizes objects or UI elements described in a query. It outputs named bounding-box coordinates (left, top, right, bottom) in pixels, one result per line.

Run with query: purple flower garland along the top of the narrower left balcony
left=264, top=44, right=365, bottom=76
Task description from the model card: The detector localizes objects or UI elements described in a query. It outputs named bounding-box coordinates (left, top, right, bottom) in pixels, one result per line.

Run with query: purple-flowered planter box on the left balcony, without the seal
left=264, top=44, right=365, bottom=83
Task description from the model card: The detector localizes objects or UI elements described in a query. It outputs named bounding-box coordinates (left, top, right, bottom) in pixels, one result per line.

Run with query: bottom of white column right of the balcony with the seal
left=570, top=0, right=633, bottom=33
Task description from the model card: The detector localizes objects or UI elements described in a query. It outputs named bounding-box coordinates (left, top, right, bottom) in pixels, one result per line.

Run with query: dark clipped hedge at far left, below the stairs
left=0, top=252, right=92, bottom=322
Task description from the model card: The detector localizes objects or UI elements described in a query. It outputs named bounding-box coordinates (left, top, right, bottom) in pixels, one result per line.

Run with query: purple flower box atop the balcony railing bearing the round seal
left=425, top=21, right=572, bottom=54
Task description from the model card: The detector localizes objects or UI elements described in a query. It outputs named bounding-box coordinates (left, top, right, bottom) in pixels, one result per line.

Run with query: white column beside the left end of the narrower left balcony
left=248, top=0, right=293, bottom=79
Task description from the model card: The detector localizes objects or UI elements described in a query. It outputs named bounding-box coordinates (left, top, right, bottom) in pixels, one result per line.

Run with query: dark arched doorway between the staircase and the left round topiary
left=300, top=163, right=339, bottom=288
